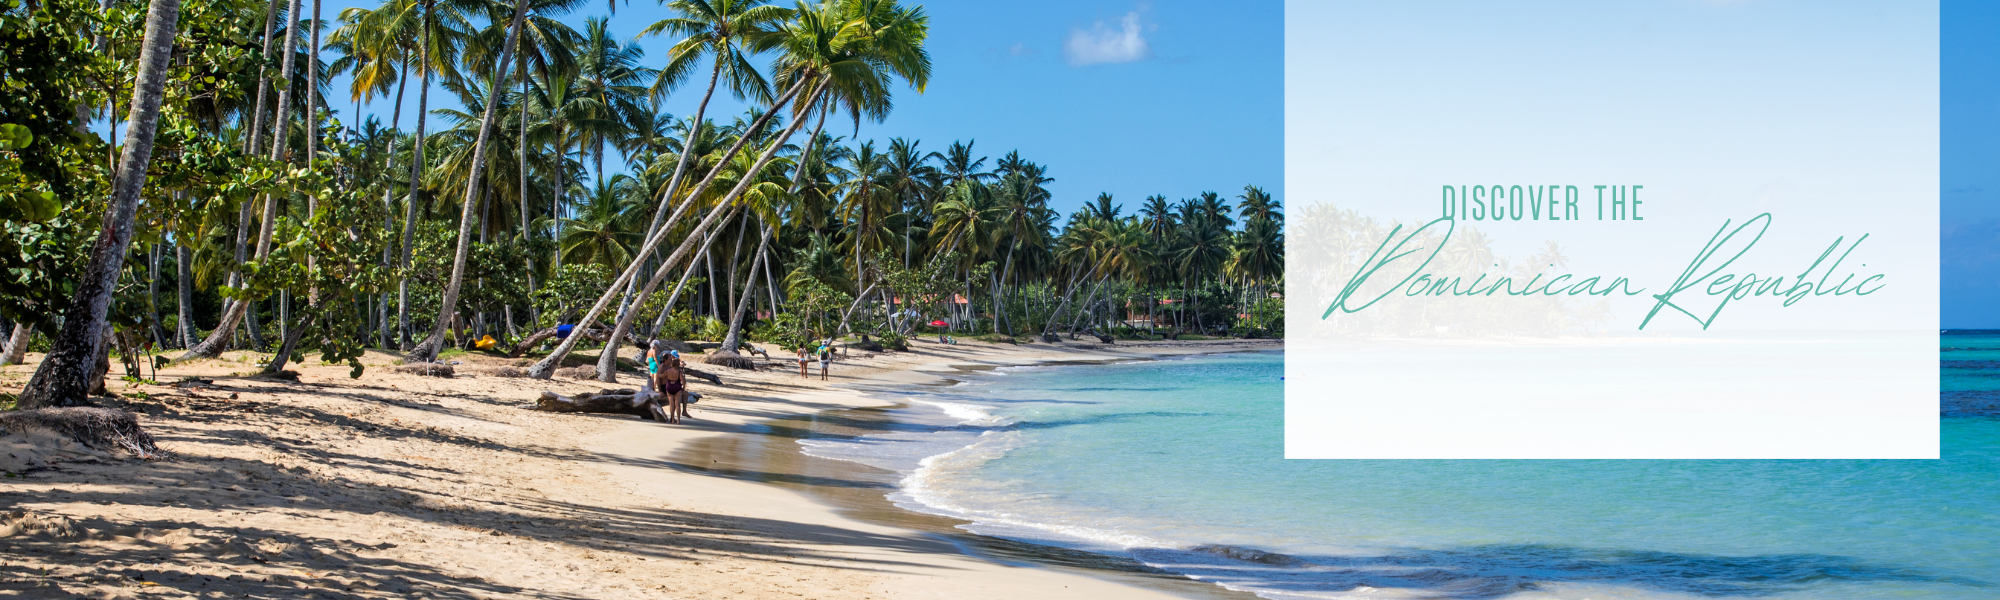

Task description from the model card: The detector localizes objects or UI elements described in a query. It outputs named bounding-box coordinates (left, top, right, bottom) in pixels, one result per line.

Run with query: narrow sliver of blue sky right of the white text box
left=1938, top=0, right=2000, bottom=328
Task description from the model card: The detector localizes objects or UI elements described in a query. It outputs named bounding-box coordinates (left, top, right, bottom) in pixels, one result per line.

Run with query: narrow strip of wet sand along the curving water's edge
left=592, top=340, right=1282, bottom=600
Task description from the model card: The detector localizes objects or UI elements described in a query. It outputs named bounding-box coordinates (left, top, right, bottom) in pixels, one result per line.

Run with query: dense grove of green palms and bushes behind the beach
left=0, top=0, right=1284, bottom=406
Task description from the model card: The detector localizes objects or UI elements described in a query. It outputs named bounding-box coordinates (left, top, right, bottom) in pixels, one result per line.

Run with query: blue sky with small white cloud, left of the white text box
left=306, top=0, right=1284, bottom=214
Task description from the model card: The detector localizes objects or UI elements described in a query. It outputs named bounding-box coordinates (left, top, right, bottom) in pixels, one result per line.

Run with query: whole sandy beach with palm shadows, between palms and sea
left=0, top=342, right=1278, bottom=598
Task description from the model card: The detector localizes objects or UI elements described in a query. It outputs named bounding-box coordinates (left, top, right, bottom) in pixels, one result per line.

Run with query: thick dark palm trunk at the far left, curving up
left=16, top=0, right=180, bottom=408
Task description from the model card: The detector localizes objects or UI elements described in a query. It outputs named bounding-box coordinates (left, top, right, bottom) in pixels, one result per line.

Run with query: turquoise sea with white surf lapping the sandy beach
left=802, top=346, right=2000, bottom=598
